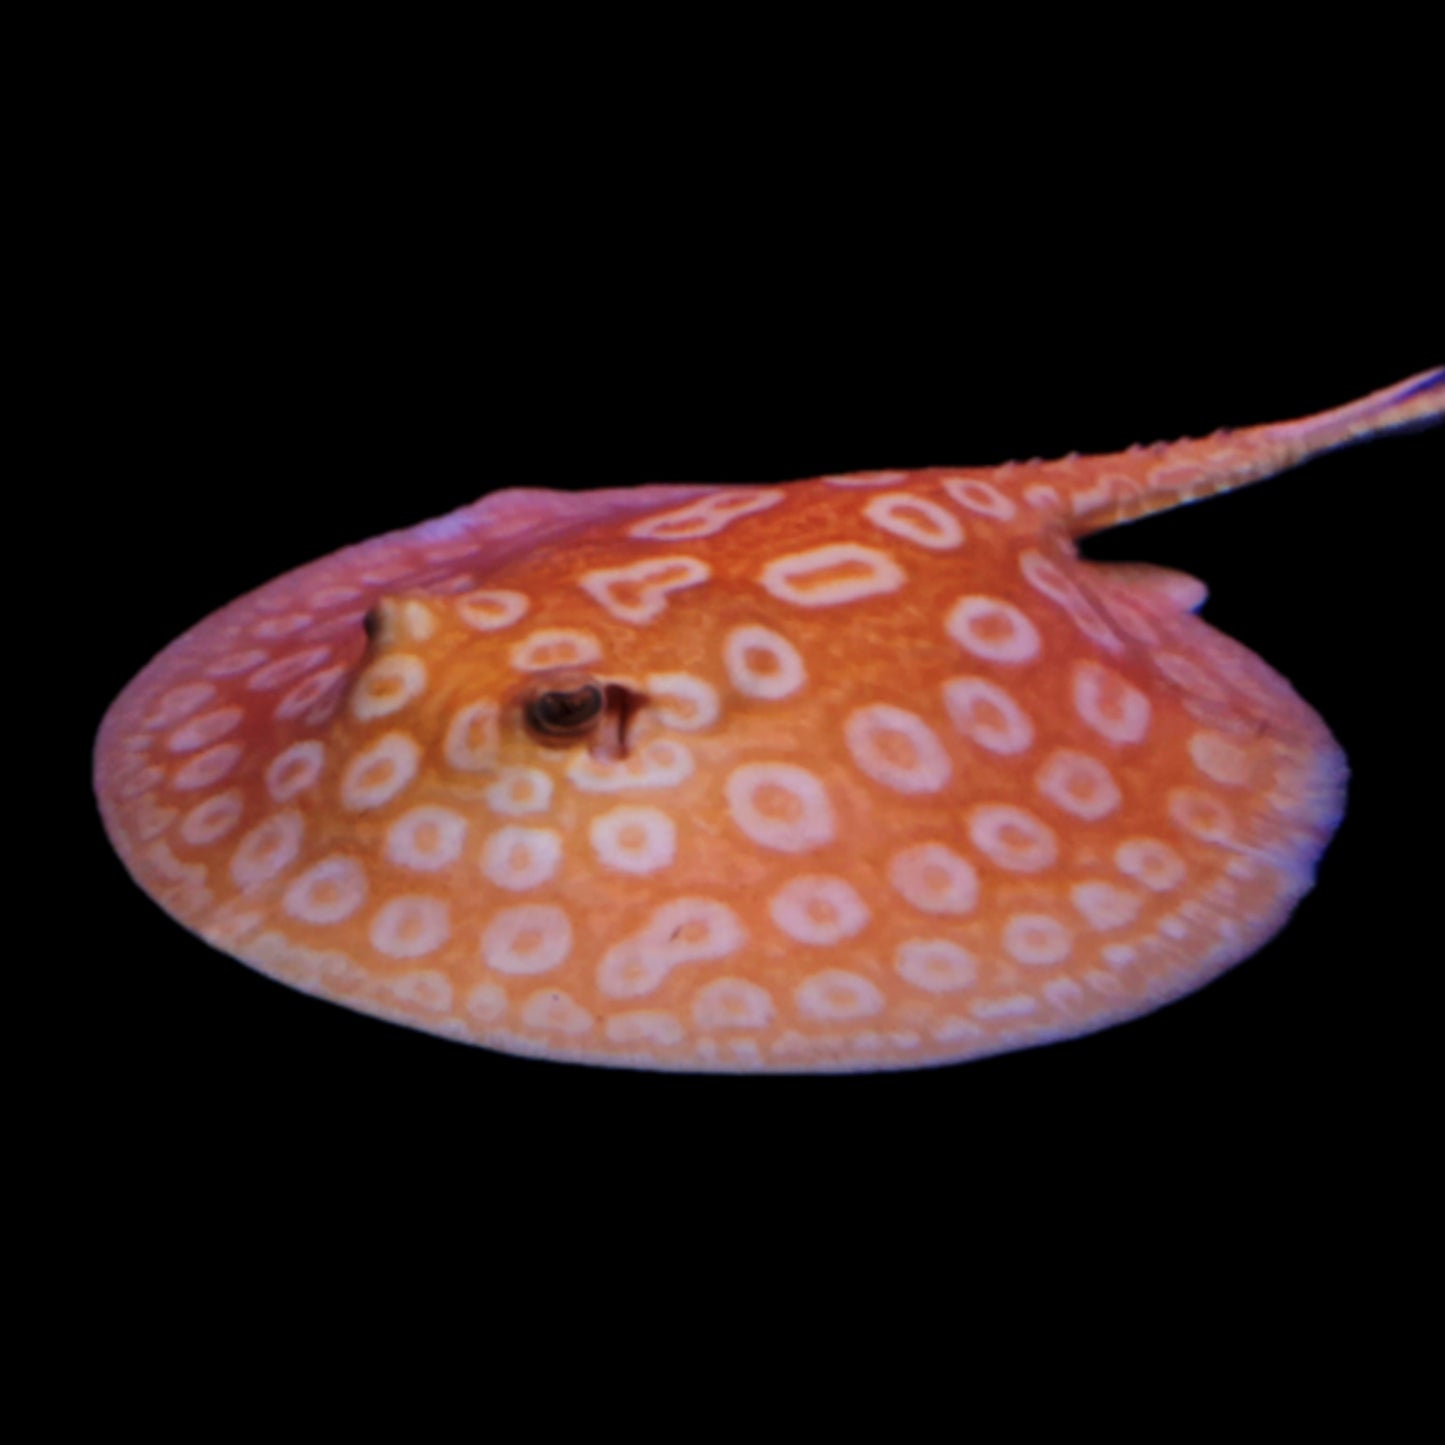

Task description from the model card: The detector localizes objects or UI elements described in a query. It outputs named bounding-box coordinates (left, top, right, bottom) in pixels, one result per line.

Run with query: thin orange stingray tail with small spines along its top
left=1068, top=367, right=1445, bottom=536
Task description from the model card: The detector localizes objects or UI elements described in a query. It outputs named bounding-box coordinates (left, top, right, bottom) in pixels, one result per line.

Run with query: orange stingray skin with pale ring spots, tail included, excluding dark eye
left=95, top=373, right=1442, bottom=1071
